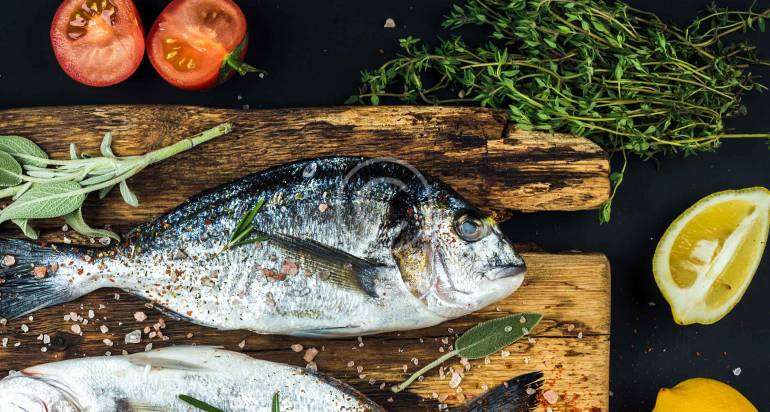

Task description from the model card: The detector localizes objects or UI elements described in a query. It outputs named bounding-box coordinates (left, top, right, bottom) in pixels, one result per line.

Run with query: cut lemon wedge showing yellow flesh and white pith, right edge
left=652, top=187, right=770, bottom=325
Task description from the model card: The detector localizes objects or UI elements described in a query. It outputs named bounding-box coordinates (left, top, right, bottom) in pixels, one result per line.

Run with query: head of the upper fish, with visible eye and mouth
left=391, top=183, right=526, bottom=319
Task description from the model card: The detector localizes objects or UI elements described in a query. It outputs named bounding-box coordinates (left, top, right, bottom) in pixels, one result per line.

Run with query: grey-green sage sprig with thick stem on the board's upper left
left=0, top=123, right=232, bottom=240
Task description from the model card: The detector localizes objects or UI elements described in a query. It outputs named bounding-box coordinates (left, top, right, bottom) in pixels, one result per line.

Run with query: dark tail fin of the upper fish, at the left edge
left=0, top=239, right=90, bottom=319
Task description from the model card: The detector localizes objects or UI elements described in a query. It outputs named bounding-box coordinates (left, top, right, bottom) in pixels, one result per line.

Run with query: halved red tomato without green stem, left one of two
left=51, top=0, right=144, bottom=87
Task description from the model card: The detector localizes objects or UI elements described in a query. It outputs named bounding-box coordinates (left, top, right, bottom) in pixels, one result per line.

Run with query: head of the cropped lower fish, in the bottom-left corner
left=0, top=372, right=82, bottom=412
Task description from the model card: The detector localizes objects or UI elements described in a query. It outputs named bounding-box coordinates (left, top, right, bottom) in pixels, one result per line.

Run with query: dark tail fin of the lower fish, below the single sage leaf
left=450, top=372, right=543, bottom=412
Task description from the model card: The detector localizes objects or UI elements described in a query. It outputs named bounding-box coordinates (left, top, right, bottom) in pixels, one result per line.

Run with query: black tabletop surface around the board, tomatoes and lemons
left=0, top=0, right=770, bottom=410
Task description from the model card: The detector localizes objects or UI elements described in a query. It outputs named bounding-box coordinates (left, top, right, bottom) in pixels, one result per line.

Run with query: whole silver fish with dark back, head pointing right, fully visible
left=0, top=157, right=525, bottom=337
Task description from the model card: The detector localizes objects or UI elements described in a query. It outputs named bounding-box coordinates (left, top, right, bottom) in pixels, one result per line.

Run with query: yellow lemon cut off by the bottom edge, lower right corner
left=652, top=378, right=757, bottom=412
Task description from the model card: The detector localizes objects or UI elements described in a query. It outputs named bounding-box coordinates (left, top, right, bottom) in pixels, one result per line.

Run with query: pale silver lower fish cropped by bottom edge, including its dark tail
left=0, top=346, right=542, bottom=412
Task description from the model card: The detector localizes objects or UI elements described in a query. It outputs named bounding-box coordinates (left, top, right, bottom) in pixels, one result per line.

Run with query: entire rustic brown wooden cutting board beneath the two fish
left=0, top=106, right=610, bottom=411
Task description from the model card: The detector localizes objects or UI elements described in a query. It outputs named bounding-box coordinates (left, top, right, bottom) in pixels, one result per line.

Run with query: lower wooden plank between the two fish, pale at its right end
left=0, top=253, right=610, bottom=411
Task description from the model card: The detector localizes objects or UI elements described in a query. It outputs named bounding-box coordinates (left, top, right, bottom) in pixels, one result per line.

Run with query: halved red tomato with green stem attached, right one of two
left=147, top=0, right=260, bottom=90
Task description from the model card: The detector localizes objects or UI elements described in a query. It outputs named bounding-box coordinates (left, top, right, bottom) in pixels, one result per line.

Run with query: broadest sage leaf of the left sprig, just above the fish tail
left=0, top=181, right=86, bottom=223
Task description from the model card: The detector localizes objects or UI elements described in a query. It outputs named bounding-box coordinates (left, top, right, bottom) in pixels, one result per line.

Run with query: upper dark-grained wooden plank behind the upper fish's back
left=0, top=106, right=609, bottom=227
